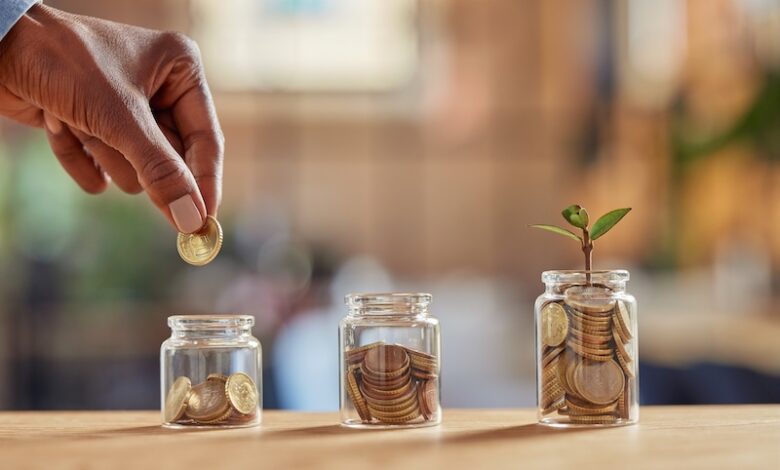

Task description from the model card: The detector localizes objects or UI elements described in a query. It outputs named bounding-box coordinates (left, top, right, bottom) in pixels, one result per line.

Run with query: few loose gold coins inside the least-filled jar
left=164, top=372, right=259, bottom=425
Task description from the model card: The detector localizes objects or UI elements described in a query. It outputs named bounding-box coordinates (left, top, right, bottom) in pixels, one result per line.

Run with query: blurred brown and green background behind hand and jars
left=0, top=0, right=780, bottom=410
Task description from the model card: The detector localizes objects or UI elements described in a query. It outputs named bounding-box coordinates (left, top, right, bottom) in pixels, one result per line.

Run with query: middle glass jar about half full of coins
left=339, top=293, right=441, bottom=428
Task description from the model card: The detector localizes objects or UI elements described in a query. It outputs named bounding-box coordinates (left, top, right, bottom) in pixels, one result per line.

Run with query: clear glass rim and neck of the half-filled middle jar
left=345, top=293, right=431, bottom=318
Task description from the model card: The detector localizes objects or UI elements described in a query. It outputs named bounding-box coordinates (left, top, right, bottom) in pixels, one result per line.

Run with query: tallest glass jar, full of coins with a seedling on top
left=535, top=270, right=639, bottom=427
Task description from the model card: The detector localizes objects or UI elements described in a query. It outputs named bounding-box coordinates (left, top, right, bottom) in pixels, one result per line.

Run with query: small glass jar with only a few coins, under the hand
left=160, top=315, right=263, bottom=427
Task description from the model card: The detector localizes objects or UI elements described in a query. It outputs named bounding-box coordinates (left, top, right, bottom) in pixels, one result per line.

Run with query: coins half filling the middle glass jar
left=345, top=342, right=439, bottom=425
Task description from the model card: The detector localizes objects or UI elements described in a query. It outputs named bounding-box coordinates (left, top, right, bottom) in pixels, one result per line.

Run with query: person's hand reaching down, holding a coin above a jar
left=0, top=5, right=224, bottom=233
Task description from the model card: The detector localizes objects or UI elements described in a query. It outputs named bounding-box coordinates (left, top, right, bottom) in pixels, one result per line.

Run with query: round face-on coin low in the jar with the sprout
left=573, top=359, right=626, bottom=405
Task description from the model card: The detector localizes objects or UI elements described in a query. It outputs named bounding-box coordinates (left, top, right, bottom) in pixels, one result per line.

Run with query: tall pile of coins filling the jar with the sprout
left=539, top=286, right=636, bottom=424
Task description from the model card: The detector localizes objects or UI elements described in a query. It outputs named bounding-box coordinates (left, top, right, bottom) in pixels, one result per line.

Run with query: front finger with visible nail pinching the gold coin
left=103, top=98, right=206, bottom=233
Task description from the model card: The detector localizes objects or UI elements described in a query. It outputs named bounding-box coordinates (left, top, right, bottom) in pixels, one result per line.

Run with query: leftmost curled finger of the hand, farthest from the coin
left=43, top=113, right=108, bottom=194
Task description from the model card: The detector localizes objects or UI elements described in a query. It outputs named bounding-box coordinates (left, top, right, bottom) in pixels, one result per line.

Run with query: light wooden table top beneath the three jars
left=0, top=405, right=780, bottom=470
